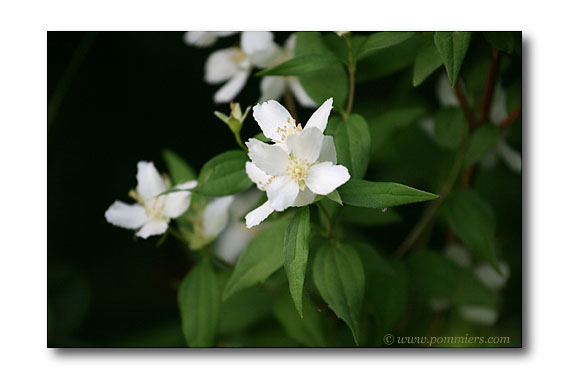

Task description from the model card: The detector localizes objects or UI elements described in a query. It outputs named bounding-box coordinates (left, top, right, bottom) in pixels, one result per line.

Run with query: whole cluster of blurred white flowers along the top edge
left=184, top=32, right=316, bottom=107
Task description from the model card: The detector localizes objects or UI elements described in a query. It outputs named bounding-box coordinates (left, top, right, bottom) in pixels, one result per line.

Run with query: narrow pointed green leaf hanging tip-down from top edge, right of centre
left=433, top=32, right=471, bottom=87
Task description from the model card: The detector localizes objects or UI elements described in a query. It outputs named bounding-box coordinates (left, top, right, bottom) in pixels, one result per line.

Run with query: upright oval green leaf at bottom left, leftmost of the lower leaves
left=178, top=260, right=220, bottom=347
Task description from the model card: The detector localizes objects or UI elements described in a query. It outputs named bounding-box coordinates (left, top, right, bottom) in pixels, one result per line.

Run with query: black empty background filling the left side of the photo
left=47, top=32, right=318, bottom=346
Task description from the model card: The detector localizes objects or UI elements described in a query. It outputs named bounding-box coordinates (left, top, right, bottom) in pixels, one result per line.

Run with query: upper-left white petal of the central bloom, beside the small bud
left=253, top=100, right=295, bottom=141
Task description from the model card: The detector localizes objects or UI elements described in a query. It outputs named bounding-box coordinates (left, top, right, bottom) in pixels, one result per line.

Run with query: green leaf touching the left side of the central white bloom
left=196, top=150, right=253, bottom=197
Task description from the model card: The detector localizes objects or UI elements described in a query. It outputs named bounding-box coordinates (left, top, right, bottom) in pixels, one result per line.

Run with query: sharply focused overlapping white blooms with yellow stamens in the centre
left=245, top=98, right=350, bottom=228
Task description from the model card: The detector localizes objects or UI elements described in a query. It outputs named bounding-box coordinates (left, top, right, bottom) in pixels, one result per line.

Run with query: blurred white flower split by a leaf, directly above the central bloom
left=259, top=34, right=317, bottom=107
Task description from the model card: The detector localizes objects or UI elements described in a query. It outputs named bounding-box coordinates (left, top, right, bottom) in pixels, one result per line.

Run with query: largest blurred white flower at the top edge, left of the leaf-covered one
left=205, top=32, right=279, bottom=103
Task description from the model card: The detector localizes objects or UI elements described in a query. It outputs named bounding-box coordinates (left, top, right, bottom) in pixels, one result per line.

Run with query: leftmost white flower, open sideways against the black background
left=105, top=161, right=197, bottom=239
